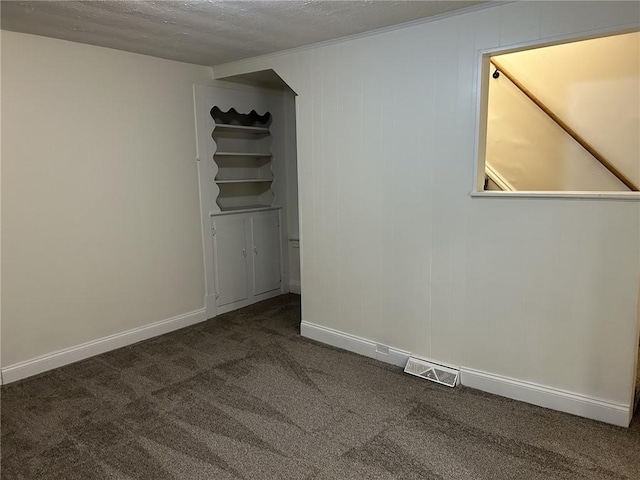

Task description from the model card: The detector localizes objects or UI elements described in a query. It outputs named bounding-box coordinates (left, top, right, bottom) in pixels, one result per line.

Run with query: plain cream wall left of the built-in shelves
left=2, top=31, right=211, bottom=367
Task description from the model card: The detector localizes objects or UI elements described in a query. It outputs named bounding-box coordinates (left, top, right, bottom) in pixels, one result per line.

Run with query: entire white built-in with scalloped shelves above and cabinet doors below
left=194, top=85, right=291, bottom=317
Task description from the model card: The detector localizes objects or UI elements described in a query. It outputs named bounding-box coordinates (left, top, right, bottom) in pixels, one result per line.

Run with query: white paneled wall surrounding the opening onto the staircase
left=214, top=2, right=640, bottom=416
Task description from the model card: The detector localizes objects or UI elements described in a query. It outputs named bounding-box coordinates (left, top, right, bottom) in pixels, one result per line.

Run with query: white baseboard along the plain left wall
left=2, top=308, right=207, bottom=383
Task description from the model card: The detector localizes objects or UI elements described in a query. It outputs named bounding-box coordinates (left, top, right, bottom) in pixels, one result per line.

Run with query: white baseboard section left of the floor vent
left=300, top=320, right=411, bottom=367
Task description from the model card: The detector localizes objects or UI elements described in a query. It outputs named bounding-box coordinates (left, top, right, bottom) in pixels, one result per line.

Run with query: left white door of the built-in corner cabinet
left=213, top=216, right=249, bottom=307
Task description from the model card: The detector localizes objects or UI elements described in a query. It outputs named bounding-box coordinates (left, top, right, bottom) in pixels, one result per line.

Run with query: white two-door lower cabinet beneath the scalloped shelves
left=212, top=208, right=282, bottom=313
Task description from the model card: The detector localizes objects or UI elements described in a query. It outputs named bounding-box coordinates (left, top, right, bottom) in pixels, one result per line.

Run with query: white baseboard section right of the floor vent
left=460, top=367, right=631, bottom=427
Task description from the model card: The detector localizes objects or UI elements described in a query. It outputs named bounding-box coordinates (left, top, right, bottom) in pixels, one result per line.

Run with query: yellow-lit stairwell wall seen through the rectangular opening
left=487, top=32, right=640, bottom=191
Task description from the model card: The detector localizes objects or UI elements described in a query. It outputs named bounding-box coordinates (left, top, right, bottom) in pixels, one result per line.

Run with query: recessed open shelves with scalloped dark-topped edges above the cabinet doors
left=210, top=107, right=274, bottom=212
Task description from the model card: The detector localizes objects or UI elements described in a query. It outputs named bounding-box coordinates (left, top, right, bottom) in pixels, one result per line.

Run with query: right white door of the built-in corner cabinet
left=251, top=211, right=281, bottom=295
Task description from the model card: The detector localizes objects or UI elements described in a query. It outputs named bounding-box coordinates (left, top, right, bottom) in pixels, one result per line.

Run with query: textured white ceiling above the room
left=0, top=0, right=484, bottom=66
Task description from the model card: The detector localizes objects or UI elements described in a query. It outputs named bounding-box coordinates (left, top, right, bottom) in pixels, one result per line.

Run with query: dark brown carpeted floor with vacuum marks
left=2, top=295, right=640, bottom=480
